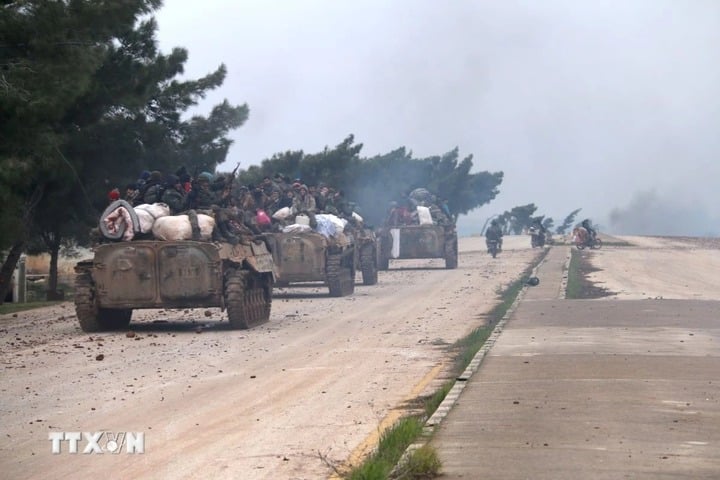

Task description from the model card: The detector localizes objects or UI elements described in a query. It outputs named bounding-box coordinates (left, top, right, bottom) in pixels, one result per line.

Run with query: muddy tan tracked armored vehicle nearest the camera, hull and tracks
left=75, top=238, right=274, bottom=332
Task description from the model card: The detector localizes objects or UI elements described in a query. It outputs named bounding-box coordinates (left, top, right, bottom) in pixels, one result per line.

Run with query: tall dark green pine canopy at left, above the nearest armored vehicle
left=0, top=0, right=248, bottom=298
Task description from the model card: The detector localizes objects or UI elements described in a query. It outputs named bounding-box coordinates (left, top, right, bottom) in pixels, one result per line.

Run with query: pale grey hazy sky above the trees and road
left=156, top=0, right=720, bottom=235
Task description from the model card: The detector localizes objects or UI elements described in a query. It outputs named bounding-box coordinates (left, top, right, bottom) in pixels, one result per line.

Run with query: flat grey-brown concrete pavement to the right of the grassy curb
left=431, top=248, right=720, bottom=480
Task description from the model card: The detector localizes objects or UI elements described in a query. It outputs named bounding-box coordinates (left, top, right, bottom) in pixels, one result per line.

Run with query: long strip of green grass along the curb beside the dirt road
left=344, top=249, right=548, bottom=480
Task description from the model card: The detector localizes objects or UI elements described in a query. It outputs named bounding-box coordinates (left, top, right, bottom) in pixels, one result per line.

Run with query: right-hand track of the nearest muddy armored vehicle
left=225, top=268, right=272, bottom=329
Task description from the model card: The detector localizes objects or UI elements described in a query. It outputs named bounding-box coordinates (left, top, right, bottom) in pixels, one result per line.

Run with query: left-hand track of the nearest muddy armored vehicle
left=75, top=267, right=132, bottom=332
